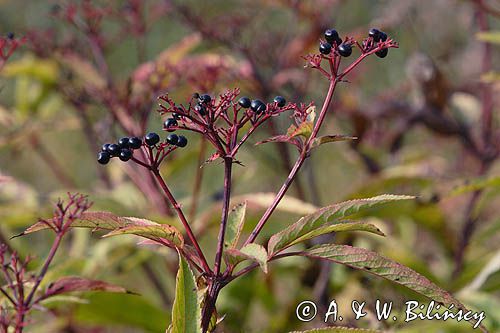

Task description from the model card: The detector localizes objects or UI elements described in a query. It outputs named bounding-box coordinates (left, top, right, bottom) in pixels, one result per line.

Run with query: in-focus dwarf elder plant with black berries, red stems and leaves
left=13, top=29, right=486, bottom=332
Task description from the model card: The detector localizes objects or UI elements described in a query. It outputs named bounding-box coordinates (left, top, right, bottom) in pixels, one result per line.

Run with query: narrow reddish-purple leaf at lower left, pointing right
left=42, top=276, right=131, bottom=299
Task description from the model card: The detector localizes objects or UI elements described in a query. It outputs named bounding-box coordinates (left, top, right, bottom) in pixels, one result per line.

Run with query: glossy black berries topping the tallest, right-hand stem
left=319, top=28, right=389, bottom=58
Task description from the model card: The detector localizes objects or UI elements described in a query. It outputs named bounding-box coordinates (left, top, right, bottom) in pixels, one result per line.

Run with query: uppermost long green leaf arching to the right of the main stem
left=268, top=194, right=414, bottom=256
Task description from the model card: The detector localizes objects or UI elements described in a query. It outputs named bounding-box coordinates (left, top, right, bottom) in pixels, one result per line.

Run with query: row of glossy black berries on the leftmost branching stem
left=97, top=132, right=187, bottom=164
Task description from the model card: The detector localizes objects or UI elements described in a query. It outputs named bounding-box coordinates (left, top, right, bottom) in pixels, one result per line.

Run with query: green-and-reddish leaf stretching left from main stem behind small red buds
left=18, top=212, right=184, bottom=247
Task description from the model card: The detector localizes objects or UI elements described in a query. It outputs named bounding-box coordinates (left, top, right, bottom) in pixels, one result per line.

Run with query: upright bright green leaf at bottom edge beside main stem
left=171, top=254, right=201, bottom=333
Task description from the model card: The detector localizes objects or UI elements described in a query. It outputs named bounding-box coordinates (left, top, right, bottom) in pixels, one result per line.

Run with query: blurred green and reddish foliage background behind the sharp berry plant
left=0, top=0, right=500, bottom=332
